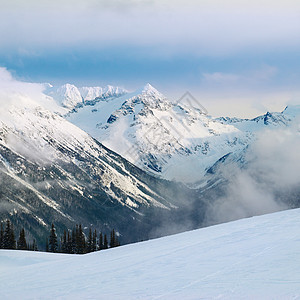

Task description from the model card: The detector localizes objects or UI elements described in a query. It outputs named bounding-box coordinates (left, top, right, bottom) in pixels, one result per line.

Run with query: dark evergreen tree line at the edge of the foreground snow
left=0, top=220, right=120, bottom=254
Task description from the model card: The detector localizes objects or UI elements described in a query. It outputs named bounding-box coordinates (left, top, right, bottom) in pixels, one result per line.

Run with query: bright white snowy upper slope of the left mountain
left=0, top=107, right=172, bottom=211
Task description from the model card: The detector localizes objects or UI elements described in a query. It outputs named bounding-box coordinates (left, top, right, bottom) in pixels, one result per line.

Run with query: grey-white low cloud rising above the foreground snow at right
left=207, top=121, right=300, bottom=223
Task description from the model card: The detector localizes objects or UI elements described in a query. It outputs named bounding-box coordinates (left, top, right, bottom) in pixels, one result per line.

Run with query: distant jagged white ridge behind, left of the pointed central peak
left=45, top=83, right=127, bottom=110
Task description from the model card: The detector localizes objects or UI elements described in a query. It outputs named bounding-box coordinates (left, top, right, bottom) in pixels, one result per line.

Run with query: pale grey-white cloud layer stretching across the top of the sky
left=0, top=0, right=300, bottom=56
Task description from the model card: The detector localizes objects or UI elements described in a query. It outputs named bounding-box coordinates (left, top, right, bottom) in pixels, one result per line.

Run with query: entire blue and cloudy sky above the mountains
left=0, top=0, right=300, bottom=117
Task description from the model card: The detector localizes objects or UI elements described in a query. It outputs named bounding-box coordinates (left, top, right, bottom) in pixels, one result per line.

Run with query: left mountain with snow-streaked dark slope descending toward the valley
left=0, top=99, right=204, bottom=243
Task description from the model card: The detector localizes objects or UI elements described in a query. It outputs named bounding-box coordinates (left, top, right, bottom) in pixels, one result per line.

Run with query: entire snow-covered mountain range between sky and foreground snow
left=0, top=84, right=299, bottom=245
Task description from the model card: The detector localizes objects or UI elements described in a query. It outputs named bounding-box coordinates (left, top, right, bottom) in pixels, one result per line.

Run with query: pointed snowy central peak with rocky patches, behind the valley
left=61, top=84, right=294, bottom=184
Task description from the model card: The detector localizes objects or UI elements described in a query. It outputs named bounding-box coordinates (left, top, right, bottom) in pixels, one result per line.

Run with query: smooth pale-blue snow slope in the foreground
left=0, top=209, right=300, bottom=299
